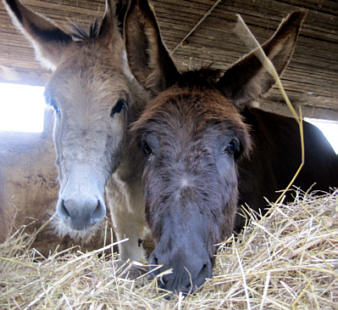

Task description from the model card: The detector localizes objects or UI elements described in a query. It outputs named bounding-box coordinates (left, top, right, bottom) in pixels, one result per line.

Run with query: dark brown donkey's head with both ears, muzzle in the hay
left=125, top=0, right=304, bottom=293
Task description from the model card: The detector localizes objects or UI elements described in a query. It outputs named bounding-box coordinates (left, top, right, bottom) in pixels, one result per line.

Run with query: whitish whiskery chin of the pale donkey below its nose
left=51, top=215, right=106, bottom=244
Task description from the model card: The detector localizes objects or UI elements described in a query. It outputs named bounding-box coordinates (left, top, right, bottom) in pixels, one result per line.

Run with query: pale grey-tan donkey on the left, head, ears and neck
left=3, top=0, right=147, bottom=260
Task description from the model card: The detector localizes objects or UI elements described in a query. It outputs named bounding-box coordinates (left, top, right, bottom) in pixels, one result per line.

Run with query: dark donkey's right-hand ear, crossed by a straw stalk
left=217, top=11, right=305, bottom=109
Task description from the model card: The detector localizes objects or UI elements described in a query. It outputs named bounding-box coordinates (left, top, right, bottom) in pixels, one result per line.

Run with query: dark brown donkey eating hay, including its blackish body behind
left=124, top=0, right=338, bottom=293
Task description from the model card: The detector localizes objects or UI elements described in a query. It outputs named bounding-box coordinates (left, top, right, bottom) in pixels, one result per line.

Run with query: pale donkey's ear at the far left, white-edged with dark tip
left=3, top=0, right=72, bottom=69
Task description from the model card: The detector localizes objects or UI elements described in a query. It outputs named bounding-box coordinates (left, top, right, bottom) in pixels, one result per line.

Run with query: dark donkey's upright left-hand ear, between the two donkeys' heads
left=124, top=0, right=179, bottom=94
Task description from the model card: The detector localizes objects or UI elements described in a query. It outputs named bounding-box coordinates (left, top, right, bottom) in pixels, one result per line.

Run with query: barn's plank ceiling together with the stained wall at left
left=0, top=0, right=338, bottom=247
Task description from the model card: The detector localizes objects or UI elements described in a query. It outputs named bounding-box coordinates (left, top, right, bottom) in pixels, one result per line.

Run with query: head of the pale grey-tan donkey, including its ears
left=4, top=0, right=136, bottom=235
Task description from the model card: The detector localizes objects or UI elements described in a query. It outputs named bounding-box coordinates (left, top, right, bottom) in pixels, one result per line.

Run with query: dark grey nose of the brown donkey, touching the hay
left=149, top=251, right=212, bottom=294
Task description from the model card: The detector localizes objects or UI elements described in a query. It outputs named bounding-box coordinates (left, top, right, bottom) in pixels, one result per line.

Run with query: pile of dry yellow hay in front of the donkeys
left=0, top=191, right=338, bottom=310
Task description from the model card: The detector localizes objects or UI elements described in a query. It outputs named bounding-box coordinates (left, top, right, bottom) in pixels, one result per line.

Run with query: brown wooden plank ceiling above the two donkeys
left=0, top=0, right=338, bottom=120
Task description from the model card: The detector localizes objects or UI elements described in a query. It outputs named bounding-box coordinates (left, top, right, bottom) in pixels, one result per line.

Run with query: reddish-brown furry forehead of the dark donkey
left=134, top=85, right=244, bottom=130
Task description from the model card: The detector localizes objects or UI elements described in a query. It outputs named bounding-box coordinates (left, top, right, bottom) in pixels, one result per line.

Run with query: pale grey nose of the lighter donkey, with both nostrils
left=57, top=198, right=106, bottom=230
